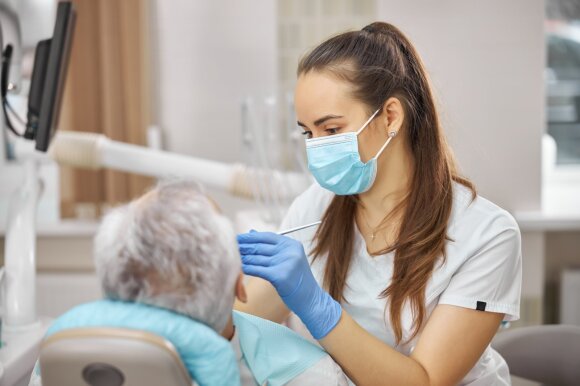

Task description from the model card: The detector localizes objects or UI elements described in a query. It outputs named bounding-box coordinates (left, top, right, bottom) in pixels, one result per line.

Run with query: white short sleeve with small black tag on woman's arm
left=439, top=213, right=522, bottom=321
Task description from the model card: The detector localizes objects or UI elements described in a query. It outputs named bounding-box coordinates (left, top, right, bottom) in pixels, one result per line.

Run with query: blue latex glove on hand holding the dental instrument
left=238, top=231, right=342, bottom=339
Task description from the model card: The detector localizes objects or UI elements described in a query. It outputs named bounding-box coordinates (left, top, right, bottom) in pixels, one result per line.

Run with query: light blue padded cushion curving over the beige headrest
left=46, top=300, right=240, bottom=386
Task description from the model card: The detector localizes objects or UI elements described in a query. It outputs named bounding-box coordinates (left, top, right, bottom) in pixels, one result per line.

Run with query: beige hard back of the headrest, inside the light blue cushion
left=39, top=328, right=192, bottom=386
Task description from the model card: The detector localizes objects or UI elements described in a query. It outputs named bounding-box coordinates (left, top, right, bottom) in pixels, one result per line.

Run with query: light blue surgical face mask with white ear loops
left=306, top=109, right=397, bottom=196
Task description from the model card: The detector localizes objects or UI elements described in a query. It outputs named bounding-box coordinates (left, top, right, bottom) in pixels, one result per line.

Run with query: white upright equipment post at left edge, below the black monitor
left=0, top=147, right=50, bottom=386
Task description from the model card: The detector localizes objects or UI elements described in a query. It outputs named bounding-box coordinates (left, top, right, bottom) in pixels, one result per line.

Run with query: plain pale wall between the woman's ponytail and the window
left=378, top=0, right=545, bottom=322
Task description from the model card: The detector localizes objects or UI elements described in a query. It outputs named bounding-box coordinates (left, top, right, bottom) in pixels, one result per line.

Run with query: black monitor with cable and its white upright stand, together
left=0, top=1, right=76, bottom=386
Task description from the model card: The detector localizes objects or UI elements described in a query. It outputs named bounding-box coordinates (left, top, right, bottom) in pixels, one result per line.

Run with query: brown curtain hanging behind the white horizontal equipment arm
left=59, top=0, right=152, bottom=218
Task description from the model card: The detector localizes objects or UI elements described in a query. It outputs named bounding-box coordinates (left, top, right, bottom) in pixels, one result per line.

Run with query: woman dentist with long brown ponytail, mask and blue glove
left=237, top=22, right=521, bottom=386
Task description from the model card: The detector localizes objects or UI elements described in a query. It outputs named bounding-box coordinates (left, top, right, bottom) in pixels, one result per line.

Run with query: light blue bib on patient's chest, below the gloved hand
left=234, top=311, right=328, bottom=386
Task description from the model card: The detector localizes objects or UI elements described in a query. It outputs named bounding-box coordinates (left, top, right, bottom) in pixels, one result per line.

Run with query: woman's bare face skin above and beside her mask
left=294, top=71, right=384, bottom=162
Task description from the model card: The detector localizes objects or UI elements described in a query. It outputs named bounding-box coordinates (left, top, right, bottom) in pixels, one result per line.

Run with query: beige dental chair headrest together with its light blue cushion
left=33, top=299, right=240, bottom=386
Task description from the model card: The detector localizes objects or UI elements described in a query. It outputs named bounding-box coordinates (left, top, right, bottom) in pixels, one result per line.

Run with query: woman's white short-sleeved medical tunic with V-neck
left=280, top=183, right=522, bottom=385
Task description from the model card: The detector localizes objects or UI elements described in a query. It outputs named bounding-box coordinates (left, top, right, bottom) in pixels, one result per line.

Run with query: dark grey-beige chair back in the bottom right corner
left=491, top=324, right=580, bottom=386
